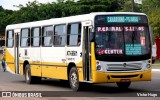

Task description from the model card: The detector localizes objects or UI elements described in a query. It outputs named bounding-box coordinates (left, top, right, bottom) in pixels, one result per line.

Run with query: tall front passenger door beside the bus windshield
left=82, top=26, right=92, bottom=81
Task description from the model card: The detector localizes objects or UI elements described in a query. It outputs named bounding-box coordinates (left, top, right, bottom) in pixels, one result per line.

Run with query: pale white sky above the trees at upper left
left=0, top=0, right=57, bottom=10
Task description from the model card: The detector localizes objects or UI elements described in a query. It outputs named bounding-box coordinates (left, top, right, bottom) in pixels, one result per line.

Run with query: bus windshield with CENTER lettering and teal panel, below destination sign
left=95, top=25, right=150, bottom=56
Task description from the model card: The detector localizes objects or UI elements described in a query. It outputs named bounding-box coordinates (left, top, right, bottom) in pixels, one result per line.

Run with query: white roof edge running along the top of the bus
left=6, top=12, right=146, bottom=30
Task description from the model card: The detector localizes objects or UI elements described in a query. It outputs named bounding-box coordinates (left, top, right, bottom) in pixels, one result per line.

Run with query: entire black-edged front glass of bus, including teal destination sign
left=95, top=15, right=151, bottom=61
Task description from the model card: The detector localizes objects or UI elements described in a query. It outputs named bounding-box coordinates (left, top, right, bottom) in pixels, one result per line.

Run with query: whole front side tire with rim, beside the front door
left=68, top=67, right=79, bottom=91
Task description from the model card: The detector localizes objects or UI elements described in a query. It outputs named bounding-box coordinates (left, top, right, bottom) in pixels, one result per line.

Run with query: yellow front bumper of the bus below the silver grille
left=92, top=69, right=151, bottom=83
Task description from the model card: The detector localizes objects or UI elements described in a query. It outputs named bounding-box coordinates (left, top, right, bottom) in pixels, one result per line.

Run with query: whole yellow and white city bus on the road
left=5, top=12, right=151, bottom=91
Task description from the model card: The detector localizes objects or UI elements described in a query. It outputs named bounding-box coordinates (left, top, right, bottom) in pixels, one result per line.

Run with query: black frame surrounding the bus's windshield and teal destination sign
left=94, top=14, right=152, bottom=62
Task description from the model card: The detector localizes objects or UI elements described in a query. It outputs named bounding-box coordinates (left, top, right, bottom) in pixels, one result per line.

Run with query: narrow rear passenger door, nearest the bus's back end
left=14, top=30, right=20, bottom=74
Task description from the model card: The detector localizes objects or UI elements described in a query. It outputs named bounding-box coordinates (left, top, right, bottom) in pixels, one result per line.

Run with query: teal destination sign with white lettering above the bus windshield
left=106, top=16, right=140, bottom=23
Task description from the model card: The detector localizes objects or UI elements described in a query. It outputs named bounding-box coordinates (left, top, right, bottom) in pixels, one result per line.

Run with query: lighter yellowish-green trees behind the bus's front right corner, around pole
left=120, top=0, right=160, bottom=36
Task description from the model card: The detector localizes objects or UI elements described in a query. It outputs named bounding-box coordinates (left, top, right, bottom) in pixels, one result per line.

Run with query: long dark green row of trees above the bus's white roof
left=0, top=0, right=124, bottom=36
